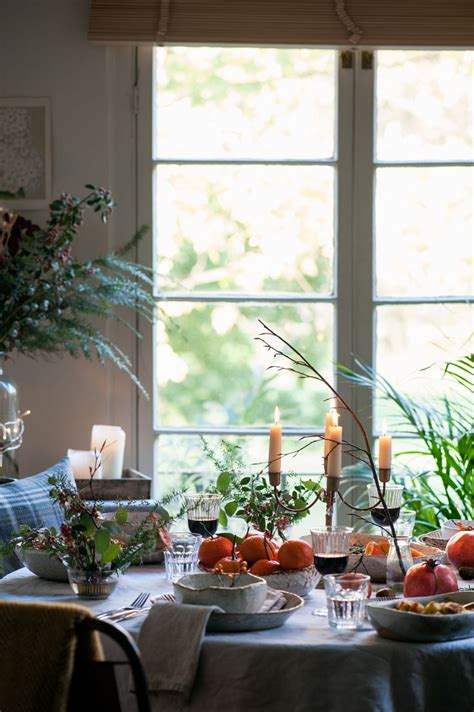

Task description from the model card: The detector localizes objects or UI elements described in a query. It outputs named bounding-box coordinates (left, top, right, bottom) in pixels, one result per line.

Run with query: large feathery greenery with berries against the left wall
left=0, top=184, right=154, bottom=390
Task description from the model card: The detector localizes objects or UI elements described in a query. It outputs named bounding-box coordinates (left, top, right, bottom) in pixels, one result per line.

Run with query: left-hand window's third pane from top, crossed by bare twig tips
left=155, top=302, right=333, bottom=427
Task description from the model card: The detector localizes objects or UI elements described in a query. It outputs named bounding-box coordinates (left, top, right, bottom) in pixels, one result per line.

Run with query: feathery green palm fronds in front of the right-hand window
left=340, top=355, right=474, bottom=534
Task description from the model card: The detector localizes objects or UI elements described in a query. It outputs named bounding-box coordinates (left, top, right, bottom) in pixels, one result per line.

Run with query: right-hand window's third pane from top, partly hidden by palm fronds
left=376, top=304, right=473, bottom=431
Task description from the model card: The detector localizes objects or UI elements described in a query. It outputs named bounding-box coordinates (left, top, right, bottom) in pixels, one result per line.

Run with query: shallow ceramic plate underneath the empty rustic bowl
left=206, top=591, right=304, bottom=633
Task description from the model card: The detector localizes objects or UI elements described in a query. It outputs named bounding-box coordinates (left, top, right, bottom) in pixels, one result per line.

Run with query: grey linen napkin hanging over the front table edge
left=138, top=603, right=221, bottom=701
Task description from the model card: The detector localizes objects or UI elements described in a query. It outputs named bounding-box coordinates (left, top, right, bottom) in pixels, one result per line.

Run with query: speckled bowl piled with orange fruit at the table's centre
left=199, top=532, right=321, bottom=596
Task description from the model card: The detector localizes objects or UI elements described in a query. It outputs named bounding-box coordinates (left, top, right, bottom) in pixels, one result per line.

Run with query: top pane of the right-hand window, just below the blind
left=376, top=50, right=474, bottom=161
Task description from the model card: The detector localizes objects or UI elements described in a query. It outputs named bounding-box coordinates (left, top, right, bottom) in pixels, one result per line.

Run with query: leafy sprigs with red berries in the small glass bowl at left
left=10, top=477, right=171, bottom=575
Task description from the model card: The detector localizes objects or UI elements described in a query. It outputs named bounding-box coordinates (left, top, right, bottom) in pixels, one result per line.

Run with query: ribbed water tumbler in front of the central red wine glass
left=324, top=574, right=370, bottom=630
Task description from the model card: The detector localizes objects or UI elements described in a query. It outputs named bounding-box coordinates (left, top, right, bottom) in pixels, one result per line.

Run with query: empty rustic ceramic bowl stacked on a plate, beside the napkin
left=173, top=573, right=267, bottom=613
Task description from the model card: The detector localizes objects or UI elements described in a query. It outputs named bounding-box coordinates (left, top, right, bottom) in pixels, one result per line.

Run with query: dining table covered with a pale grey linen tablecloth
left=0, top=565, right=474, bottom=712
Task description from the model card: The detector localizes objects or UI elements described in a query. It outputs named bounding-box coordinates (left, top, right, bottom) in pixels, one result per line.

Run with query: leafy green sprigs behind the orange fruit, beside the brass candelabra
left=203, top=439, right=319, bottom=539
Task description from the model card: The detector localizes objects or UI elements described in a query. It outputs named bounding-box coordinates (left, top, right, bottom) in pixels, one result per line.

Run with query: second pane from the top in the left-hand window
left=156, top=166, right=334, bottom=294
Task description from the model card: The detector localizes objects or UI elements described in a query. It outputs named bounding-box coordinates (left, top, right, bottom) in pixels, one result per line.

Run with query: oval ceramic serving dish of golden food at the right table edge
left=367, top=591, right=474, bottom=643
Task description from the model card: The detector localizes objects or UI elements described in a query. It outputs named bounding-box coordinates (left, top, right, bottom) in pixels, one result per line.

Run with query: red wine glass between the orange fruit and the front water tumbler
left=311, top=526, right=353, bottom=616
